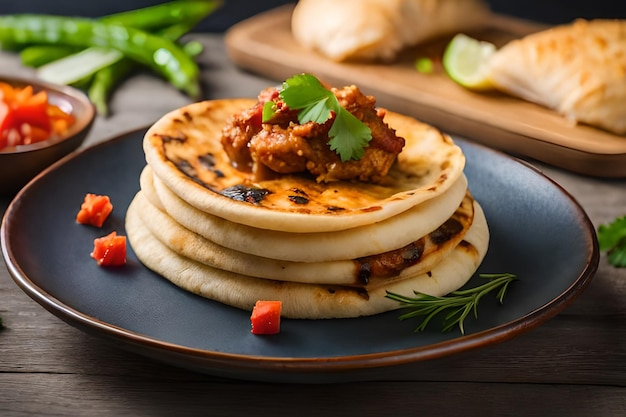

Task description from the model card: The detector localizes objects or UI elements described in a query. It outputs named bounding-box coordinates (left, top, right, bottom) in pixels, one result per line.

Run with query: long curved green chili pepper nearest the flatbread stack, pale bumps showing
left=0, top=14, right=200, bottom=97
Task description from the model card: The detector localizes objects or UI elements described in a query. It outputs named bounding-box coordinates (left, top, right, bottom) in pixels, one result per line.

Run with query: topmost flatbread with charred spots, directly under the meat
left=144, top=99, right=465, bottom=233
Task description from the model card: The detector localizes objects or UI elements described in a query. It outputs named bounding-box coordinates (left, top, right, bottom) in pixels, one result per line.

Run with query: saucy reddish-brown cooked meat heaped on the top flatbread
left=222, top=86, right=404, bottom=182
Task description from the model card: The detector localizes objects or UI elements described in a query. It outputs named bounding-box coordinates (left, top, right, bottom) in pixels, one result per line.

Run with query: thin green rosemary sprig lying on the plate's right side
left=386, top=273, right=517, bottom=334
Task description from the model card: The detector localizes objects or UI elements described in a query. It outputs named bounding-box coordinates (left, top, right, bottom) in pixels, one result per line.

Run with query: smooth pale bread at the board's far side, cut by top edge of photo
left=291, top=0, right=489, bottom=61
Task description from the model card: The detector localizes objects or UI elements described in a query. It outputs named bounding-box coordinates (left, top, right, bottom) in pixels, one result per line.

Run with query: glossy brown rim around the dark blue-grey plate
left=0, top=127, right=600, bottom=380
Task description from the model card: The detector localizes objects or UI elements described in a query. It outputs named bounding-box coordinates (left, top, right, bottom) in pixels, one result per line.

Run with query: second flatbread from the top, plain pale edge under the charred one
left=146, top=167, right=467, bottom=262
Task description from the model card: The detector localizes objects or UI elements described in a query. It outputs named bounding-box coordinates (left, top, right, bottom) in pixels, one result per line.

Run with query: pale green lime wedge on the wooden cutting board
left=443, top=33, right=496, bottom=90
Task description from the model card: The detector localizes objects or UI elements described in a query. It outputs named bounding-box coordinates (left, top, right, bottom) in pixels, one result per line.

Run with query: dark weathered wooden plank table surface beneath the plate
left=0, top=34, right=626, bottom=417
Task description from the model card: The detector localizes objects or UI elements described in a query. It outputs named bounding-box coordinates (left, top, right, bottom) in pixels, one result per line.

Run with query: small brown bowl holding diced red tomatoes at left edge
left=0, top=76, right=96, bottom=196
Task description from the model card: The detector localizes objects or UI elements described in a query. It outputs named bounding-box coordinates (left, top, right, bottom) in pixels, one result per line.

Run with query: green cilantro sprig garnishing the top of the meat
left=263, top=74, right=372, bottom=162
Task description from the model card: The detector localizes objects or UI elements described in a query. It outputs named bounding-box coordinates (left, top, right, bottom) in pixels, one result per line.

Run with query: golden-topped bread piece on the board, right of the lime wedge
left=490, top=19, right=626, bottom=135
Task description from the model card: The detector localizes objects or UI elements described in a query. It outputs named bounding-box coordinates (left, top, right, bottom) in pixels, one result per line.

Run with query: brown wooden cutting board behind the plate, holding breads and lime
left=226, top=6, right=626, bottom=177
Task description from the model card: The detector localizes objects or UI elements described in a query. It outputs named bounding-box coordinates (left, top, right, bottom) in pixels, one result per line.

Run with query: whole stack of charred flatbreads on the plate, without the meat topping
left=126, top=99, right=489, bottom=319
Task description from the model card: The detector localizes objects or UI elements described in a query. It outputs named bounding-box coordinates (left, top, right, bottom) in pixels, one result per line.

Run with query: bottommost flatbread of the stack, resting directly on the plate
left=126, top=195, right=489, bottom=319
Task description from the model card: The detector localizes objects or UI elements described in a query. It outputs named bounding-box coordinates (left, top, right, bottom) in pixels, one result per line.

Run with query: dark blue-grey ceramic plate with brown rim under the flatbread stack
left=2, top=131, right=599, bottom=382
